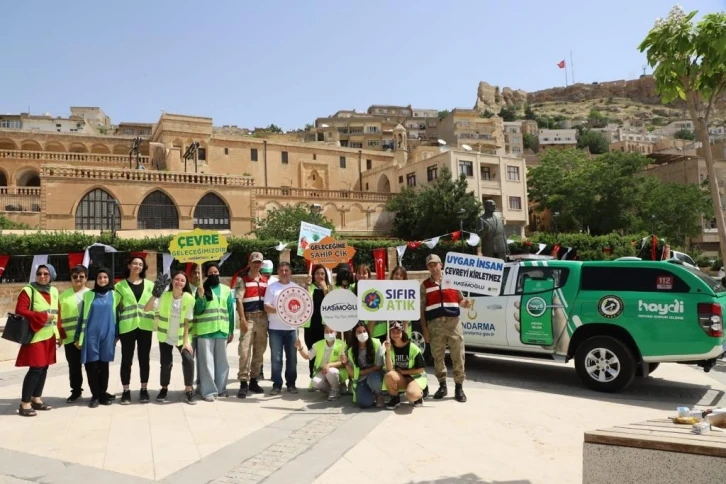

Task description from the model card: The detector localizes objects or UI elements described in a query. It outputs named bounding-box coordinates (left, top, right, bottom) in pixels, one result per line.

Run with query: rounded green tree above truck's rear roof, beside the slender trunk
left=638, top=177, right=713, bottom=245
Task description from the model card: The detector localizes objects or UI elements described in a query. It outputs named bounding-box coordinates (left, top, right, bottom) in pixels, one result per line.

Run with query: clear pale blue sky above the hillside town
left=0, top=0, right=726, bottom=129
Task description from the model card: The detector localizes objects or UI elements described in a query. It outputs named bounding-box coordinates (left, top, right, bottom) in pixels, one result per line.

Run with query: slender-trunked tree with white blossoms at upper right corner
left=638, top=5, right=726, bottom=260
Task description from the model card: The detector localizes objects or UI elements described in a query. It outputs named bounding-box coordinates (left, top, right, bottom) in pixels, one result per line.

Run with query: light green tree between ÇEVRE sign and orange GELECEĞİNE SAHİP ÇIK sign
left=252, top=203, right=335, bottom=242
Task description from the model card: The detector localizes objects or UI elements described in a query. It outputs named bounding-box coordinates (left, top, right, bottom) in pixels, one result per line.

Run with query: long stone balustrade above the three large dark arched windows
left=40, top=165, right=255, bottom=187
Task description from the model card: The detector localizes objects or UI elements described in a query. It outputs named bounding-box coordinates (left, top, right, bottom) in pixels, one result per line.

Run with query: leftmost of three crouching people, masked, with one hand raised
left=295, top=326, right=348, bottom=401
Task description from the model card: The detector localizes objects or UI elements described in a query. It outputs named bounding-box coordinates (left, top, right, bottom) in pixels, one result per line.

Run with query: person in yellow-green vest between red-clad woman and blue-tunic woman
left=58, top=265, right=88, bottom=403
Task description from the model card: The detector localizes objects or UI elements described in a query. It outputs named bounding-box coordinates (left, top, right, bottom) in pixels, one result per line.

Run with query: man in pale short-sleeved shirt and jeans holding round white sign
left=265, top=262, right=307, bottom=395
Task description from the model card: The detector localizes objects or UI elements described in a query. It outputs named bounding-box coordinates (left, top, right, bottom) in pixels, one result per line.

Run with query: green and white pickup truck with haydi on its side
left=413, top=258, right=726, bottom=392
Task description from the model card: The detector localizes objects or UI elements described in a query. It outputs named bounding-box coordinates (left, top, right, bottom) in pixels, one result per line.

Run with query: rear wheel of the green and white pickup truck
left=575, top=336, right=635, bottom=393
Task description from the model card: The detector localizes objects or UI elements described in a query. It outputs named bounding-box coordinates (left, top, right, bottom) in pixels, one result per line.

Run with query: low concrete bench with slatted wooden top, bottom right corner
left=582, top=419, right=726, bottom=484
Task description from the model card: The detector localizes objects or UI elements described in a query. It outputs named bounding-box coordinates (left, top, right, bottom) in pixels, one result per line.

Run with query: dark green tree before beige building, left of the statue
left=386, top=167, right=481, bottom=240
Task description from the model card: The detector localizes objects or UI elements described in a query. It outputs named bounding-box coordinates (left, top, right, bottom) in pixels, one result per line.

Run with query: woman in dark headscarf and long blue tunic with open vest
left=75, top=268, right=121, bottom=408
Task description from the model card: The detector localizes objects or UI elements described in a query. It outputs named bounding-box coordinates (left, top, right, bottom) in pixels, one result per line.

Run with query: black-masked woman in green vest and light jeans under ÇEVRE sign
left=194, top=262, right=235, bottom=402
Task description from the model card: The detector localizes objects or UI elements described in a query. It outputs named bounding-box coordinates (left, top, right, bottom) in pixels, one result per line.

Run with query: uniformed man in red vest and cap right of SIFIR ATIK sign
left=421, top=254, right=471, bottom=403
